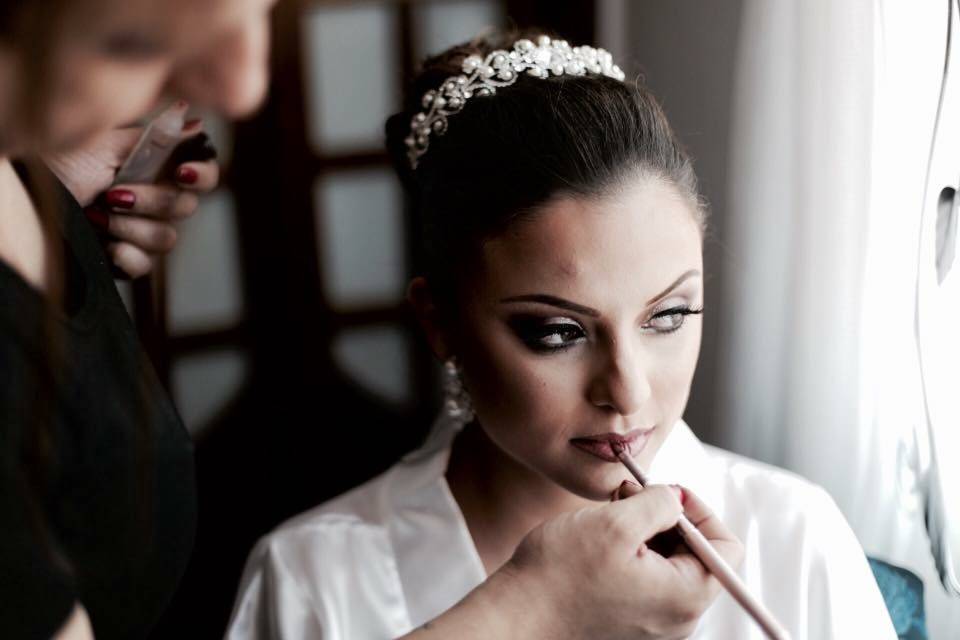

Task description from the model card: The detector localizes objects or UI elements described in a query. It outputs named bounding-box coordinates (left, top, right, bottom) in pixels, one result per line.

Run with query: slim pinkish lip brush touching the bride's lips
left=611, top=442, right=790, bottom=640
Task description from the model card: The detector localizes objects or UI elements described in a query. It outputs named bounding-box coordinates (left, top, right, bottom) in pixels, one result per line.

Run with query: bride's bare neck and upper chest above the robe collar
left=447, top=424, right=590, bottom=575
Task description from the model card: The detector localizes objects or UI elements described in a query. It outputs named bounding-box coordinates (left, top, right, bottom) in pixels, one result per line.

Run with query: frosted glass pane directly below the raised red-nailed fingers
left=167, top=191, right=242, bottom=333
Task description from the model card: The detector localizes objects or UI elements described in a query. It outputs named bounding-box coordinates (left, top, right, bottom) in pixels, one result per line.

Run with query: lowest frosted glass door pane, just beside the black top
left=171, top=350, right=248, bottom=436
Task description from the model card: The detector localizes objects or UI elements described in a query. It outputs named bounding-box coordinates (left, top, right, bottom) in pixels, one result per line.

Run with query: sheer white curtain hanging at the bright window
left=716, top=0, right=960, bottom=640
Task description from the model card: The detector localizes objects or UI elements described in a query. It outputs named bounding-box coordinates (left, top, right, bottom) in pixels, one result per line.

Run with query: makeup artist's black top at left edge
left=0, top=162, right=196, bottom=640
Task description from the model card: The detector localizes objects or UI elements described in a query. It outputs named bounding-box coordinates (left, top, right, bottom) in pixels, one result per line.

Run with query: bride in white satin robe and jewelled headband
left=228, top=27, right=895, bottom=640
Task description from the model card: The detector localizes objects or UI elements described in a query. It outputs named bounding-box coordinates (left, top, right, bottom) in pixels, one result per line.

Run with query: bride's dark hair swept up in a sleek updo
left=386, top=31, right=706, bottom=302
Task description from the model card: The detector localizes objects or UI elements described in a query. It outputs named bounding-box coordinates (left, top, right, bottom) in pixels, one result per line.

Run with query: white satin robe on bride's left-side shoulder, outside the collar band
left=228, top=460, right=424, bottom=638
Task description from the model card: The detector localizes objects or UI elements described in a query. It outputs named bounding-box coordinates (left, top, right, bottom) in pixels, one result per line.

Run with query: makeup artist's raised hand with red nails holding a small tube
left=43, top=120, right=220, bottom=278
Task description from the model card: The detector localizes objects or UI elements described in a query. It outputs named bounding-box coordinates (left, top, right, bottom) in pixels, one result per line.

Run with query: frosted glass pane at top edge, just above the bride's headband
left=413, top=0, right=503, bottom=59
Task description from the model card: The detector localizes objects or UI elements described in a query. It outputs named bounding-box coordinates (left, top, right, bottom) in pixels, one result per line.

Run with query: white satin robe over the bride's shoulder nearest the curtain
left=703, top=447, right=896, bottom=638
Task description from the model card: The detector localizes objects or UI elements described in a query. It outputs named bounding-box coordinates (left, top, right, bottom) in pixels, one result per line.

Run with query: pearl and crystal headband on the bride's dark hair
left=404, top=36, right=624, bottom=169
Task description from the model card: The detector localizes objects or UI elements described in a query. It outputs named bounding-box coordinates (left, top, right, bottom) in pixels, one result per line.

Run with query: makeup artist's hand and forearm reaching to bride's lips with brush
left=404, top=486, right=743, bottom=640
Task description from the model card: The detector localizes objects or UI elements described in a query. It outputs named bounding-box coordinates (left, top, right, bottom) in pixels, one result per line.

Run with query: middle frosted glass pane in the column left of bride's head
left=316, top=169, right=406, bottom=307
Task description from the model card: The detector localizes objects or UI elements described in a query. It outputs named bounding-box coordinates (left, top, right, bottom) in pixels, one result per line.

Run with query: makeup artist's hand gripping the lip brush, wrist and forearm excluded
left=498, top=486, right=736, bottom=639
